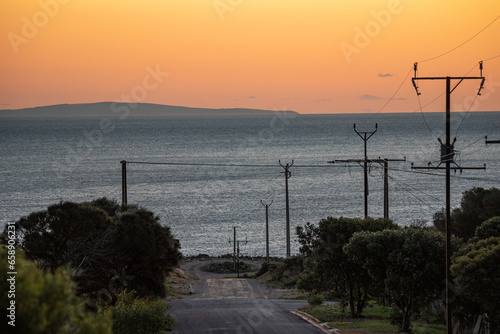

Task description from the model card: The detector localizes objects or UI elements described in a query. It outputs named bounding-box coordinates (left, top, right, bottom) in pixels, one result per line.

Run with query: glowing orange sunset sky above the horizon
left=0, top=0, right=500, bottom=113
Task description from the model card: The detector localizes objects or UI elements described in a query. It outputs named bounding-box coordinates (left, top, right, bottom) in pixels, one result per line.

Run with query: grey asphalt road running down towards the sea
left=168, top=263, right=323, bottom=334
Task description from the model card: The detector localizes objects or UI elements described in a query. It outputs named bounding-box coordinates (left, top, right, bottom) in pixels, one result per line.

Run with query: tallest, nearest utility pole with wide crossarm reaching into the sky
left=411, top=62, right=485, bottom=334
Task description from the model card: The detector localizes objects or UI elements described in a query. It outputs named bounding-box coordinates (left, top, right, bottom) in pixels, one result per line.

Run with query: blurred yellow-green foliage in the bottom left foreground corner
left=0, top=247, right=111, bottom=334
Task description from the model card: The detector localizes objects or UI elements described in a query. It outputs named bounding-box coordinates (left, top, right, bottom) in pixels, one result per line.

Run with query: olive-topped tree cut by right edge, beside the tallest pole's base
left=451, top=237, right=500, bottom=333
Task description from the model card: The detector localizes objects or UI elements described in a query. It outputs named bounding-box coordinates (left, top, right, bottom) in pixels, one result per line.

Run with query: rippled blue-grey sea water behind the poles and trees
left=0, top=112, right=500, bottom=256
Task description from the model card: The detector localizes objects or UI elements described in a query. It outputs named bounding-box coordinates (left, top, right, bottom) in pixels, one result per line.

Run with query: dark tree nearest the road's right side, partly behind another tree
left=297, top=217, right=398, bottom=317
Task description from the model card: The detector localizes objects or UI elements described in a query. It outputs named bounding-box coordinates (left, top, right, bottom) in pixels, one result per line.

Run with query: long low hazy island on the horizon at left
left=0, top=102, right=298, bottom=118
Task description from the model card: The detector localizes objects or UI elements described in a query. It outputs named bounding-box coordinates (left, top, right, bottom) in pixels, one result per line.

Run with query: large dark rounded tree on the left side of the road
left=2, top=198, right=181, bottom=303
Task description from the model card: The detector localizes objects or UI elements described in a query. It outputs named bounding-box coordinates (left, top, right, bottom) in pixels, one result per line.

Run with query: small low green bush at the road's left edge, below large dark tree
left=113, top=292, right=174, bottom=334
